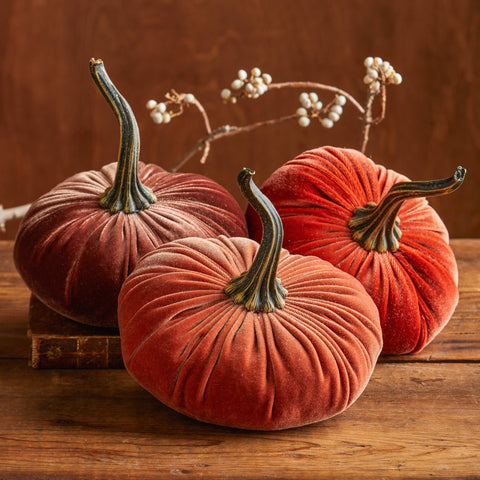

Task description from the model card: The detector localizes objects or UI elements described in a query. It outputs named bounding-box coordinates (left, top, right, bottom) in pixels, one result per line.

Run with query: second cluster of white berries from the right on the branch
left=297, top=92, right=347, bottom=128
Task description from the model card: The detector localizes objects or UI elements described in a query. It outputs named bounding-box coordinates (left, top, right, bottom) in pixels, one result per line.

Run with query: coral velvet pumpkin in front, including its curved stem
left=118, top=169, right=382, bottom=430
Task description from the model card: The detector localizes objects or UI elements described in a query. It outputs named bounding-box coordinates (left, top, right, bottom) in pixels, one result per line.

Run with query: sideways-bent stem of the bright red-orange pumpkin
left=348, top=167, right=467, bottom=253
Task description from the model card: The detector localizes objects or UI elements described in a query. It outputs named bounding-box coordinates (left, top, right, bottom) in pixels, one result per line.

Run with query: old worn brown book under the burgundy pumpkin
left=28, top=295, right=124, bottom=368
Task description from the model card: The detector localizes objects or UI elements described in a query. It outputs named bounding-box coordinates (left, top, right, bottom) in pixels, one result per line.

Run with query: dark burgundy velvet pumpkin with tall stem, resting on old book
left=14, top=59, right=247, bottom=327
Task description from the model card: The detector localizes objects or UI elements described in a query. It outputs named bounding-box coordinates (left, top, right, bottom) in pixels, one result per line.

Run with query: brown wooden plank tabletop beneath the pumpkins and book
left=0, top=239, right=480, bottom=480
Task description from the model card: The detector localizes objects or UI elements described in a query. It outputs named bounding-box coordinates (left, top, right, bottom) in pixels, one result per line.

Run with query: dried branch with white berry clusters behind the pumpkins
left=0, top=57, right=402, bottom=231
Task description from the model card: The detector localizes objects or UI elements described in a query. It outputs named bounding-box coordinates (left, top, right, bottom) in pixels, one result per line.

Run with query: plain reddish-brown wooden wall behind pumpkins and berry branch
left=0, top=0, right=480, bottom=239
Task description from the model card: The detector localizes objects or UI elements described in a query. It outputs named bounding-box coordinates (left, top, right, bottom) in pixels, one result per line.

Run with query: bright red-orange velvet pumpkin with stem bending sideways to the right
left=246, top=147, right=465, bottom=354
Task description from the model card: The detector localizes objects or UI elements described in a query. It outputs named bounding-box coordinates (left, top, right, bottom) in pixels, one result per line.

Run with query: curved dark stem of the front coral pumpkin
left=224, top=168, right=287, bottom=312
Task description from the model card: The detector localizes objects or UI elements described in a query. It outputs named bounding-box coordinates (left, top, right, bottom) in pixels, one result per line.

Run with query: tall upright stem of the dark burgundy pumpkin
left=90, top=58, right=156, bottom=213
